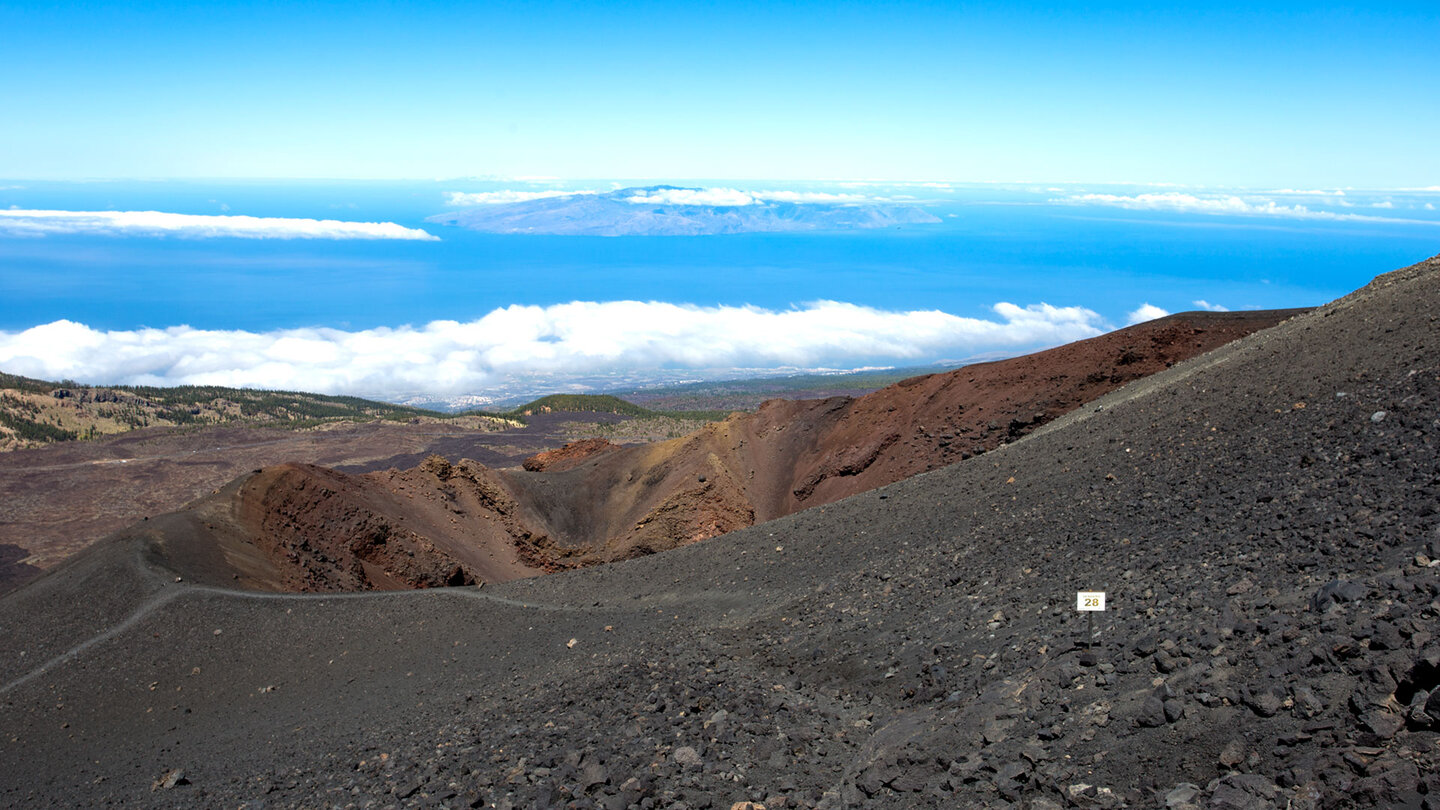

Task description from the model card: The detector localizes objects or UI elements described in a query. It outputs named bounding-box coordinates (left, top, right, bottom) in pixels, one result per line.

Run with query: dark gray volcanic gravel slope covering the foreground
left=0, top=259, right=1440, bottom=810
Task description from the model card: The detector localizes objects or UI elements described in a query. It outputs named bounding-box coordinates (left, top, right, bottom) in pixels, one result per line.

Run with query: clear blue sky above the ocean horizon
left=0, top=0, right=1440, bottom=187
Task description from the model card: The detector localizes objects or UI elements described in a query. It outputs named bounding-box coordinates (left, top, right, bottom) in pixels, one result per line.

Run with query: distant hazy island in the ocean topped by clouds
left=426, top=186, right=940, bottom=236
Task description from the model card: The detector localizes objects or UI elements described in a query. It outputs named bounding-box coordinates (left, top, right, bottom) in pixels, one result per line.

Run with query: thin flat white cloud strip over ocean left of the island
left=0, top=209, right=439, bottom=241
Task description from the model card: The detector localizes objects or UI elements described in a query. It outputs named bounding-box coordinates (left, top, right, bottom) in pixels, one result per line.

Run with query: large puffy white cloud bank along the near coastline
left=0, top=301, right=1106, bottom=395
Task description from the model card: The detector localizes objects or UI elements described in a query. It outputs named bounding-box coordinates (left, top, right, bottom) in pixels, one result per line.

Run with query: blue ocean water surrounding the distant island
left=0, top=182, right=1440, bottom=400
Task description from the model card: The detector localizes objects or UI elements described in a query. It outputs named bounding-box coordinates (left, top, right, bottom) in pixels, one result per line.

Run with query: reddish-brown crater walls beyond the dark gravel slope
left=196, top=310, right=1303, bottom=591
